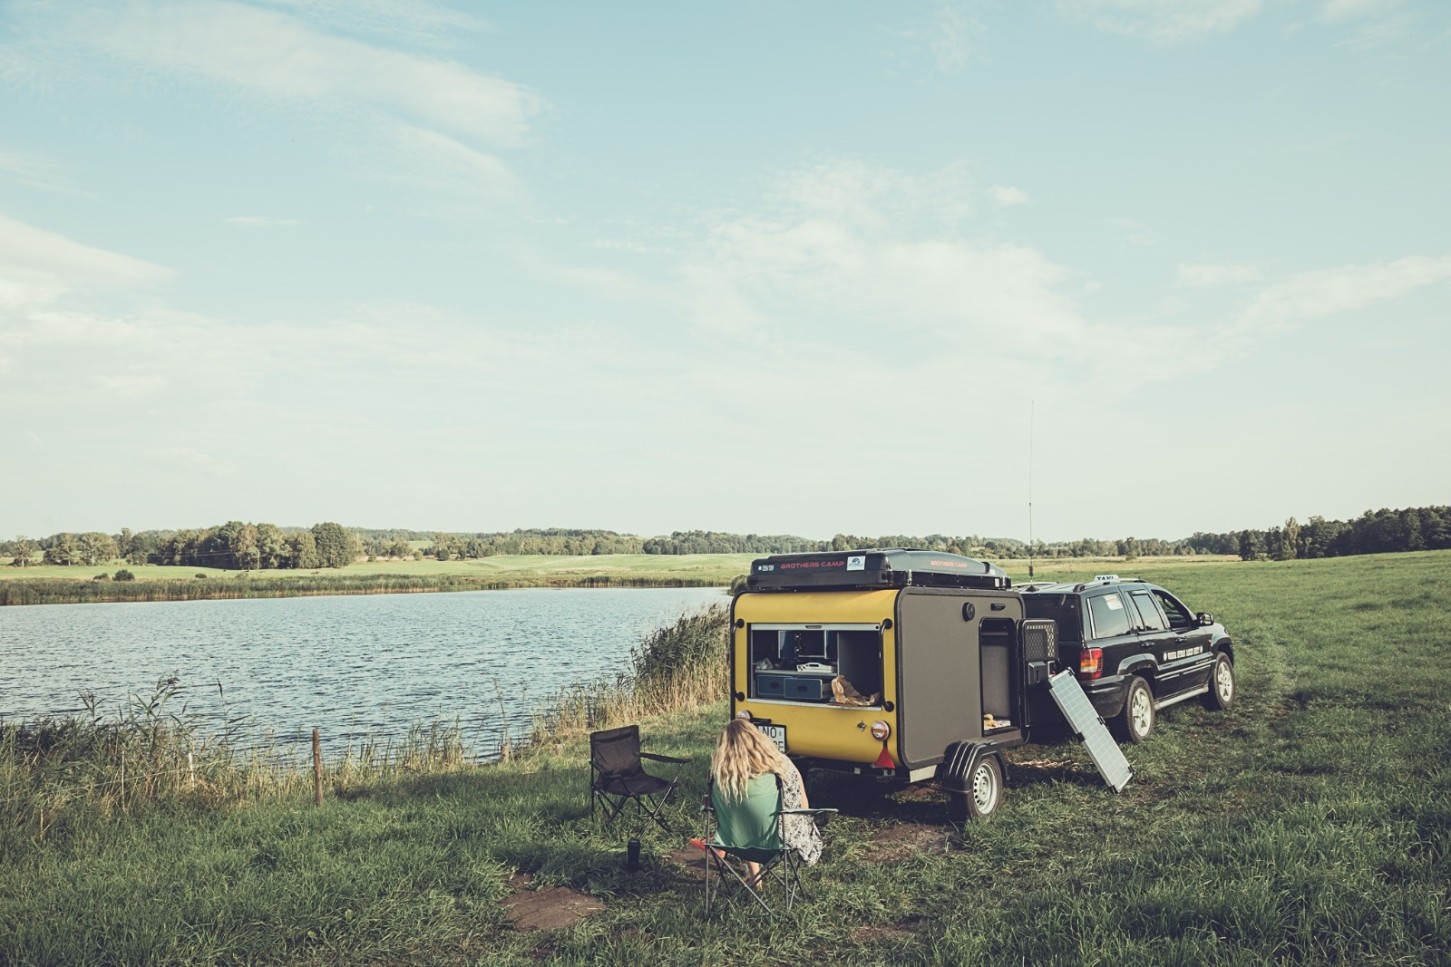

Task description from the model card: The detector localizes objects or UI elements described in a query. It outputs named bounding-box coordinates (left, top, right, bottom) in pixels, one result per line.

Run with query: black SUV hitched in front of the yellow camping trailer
left=1017, top=574, right=1235, bottom=742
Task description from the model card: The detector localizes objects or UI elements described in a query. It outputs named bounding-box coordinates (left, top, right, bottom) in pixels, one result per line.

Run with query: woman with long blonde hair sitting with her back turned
left=711, top=708, right=821, bottom=877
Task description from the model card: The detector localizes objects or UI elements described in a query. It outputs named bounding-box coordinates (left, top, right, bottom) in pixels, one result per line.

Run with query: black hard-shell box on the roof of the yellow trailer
left=746, top=547, right=1013, bottom=591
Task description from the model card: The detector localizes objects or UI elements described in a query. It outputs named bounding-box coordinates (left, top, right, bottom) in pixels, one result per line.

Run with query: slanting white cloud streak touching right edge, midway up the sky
left=1241, top=256, right=1451, bottom=328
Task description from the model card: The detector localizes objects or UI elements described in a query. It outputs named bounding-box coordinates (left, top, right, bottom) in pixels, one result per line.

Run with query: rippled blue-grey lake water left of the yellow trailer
left=0, top=588, right=727, bottom=755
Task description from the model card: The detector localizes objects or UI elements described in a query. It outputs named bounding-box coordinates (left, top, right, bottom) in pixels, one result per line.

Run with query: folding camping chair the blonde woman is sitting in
left=701, top=772, right=836, bottom=916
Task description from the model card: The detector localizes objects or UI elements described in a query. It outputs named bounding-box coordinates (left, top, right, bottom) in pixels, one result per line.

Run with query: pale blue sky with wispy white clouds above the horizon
left=0, top=0, right=1451, bottom=540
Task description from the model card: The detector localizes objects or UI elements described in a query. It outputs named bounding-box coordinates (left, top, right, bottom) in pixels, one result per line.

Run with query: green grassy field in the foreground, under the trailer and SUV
left=0, top=552, right=1451, bottom=964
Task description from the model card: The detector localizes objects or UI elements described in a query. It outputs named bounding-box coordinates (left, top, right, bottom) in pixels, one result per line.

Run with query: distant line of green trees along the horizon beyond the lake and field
left=0, top=507, right=1451, bottom=571
